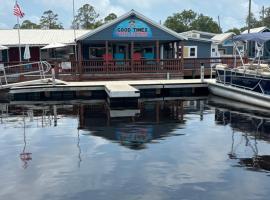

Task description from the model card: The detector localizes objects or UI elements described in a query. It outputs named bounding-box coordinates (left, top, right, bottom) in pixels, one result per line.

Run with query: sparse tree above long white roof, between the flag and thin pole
left=40, top=10, right=63, bottom=29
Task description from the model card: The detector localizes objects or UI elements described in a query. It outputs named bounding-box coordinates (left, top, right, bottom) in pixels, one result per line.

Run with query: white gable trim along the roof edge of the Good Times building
left=77, top=10, right=188, bottom=41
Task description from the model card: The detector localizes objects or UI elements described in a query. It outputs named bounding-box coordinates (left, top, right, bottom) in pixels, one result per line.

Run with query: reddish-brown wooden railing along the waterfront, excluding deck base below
left=0, top=57, right=247, bottom=77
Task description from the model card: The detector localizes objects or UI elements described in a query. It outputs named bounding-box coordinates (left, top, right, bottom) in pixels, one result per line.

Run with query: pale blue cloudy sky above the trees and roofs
left=0, top=0, right=270, bottom=31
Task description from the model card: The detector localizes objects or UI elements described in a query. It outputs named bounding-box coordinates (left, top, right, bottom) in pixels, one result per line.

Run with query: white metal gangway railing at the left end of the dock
left=0, top=61, right=51, bottom=86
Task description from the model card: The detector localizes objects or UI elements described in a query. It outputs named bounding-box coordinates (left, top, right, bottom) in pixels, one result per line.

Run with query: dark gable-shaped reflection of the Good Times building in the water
left=79, top=100, right=204, bottom=150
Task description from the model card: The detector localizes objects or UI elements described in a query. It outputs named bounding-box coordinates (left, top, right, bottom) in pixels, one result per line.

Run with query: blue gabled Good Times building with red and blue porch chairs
left=78, top=10, right=186, bottom=77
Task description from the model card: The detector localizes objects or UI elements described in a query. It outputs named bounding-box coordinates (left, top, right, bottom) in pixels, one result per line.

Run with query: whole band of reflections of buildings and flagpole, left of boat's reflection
left=1, top=99, right=205, bottom=153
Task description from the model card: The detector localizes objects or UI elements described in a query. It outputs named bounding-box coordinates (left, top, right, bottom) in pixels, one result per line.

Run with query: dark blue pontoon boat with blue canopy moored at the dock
left=209, top=32, right=270, bottom=108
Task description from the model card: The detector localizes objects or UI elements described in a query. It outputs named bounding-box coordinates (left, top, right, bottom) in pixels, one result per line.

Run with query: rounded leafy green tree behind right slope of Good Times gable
left=164, top=10, right=197, bottom=33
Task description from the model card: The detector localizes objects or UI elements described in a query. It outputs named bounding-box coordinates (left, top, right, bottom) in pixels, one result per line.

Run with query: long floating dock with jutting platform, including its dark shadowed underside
left=0, top=79, right=211, bottom=105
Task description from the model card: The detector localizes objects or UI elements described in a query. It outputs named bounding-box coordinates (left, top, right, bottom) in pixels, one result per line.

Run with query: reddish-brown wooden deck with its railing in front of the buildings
left=0, top=57, right=246, bottom=81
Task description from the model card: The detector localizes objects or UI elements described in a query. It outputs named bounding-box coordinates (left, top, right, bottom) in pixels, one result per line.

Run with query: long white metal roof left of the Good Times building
left=0, top=29, right=90, bottom=46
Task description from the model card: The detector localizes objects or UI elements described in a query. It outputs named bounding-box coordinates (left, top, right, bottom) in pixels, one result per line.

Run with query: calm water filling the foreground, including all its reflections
left=0, top=100, right=270, bottom=200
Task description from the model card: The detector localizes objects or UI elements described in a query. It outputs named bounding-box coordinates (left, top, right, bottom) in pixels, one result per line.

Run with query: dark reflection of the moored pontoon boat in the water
left=212, top=96, right=270, bottom=172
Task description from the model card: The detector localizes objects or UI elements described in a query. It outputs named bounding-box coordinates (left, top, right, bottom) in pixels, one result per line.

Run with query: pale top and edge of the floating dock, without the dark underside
left=4, top=79, right=210, bottom=93
